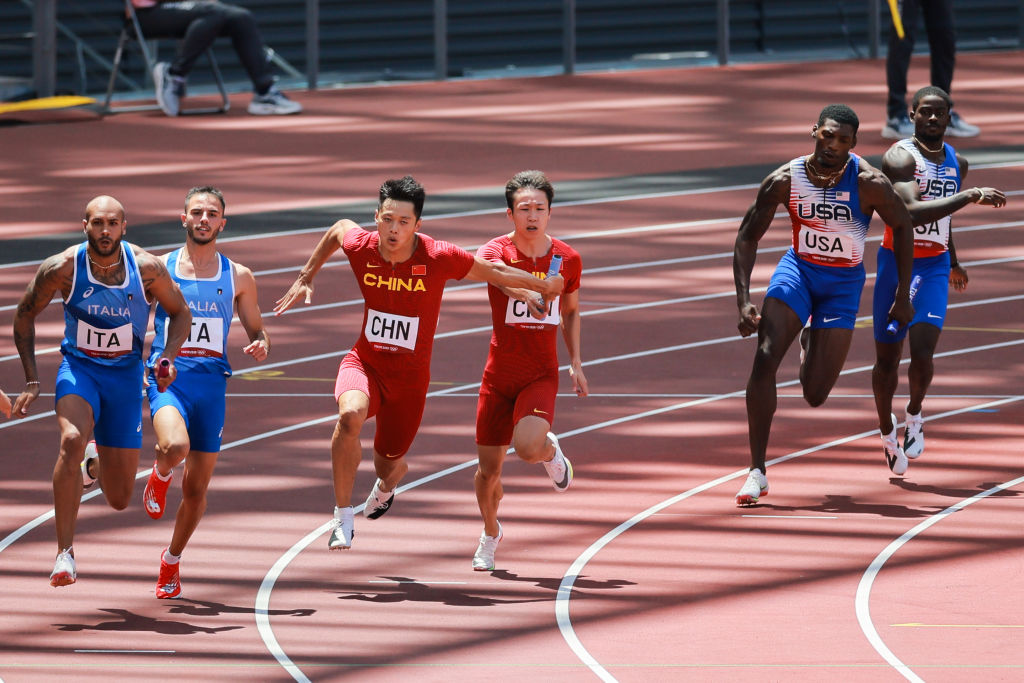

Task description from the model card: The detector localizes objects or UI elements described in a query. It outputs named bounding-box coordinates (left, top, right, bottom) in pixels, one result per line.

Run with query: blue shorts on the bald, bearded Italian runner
left=55, top=356, right=142, bottom=449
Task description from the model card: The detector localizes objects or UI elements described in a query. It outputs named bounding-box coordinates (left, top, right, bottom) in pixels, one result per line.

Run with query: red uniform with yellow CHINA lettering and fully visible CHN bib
left=334, top=228, right=473, bottom=458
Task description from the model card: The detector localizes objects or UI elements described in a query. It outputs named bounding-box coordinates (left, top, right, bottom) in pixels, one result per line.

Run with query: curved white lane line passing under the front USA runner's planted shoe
left=555, top=395, right=1024, bottom=682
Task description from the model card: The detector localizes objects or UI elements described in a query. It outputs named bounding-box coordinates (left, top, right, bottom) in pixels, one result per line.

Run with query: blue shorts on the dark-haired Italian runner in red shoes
left=145, top=370, right=227, bottom=453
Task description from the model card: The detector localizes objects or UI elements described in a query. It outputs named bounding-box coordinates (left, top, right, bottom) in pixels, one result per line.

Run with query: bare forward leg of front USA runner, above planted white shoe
left=746, top=298, right=813, bottom=472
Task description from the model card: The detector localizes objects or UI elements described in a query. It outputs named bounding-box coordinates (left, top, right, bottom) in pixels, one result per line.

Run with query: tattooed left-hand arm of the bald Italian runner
left=13, top=248, right=75, bottom=418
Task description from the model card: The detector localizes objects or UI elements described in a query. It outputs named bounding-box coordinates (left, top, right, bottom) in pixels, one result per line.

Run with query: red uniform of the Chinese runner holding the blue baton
left=476, top=233, right=583, bottom=445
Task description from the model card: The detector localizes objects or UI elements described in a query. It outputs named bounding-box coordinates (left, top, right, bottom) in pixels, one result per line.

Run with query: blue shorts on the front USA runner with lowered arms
left=765, top=248, right=866, bottom=330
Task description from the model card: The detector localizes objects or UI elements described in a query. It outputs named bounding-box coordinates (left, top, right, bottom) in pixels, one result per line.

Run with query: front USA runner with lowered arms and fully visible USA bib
left=733, top=104, right=913, bottom=505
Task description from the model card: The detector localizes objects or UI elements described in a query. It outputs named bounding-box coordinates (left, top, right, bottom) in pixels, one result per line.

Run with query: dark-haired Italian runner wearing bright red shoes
left=142, top=186, right=270, bottom=598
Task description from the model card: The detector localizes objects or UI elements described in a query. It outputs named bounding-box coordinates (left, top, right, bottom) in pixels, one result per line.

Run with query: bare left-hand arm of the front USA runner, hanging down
left=732, top=164, right=790, bottom=337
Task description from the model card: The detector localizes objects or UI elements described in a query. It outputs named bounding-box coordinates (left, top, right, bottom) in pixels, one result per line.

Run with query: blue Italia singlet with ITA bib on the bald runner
left=60, top=242, right=150, bottom=368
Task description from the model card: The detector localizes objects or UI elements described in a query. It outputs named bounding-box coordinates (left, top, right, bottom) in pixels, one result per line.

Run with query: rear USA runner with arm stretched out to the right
left=871, top=86, right=1007, bottom=471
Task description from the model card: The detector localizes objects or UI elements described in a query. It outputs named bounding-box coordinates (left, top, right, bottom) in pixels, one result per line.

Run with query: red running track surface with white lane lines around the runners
left=6, top=53, right=1024, bottom=681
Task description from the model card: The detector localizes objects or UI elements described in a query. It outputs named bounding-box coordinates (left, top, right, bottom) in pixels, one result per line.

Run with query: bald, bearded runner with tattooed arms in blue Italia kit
left=14, top=197, right=190, bottom=586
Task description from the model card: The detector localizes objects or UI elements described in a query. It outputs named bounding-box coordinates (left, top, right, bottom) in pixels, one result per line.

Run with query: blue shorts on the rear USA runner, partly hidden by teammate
left=871, top=247, right=949, bottom=344
